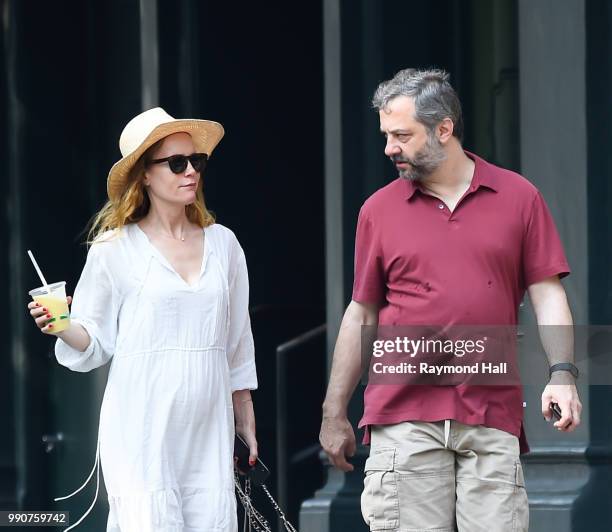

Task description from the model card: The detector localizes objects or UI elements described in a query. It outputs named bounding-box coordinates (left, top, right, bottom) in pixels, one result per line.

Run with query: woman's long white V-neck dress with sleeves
left=55, top=224, right=257, bottom=532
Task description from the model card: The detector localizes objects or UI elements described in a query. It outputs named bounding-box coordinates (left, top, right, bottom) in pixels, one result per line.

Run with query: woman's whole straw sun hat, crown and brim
left=106, top=107, right=224, bottom=201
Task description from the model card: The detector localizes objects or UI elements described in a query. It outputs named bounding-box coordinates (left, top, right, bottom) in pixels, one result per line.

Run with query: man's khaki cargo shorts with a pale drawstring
left=361, top=420, right=529, bottom=532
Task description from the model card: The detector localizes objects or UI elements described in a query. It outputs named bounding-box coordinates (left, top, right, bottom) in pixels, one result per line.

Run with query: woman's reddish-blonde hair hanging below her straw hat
left=87, top=139, right=215, bottom=245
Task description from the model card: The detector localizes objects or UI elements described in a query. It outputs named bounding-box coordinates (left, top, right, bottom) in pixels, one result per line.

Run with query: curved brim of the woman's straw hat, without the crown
left=106, top=119, right=225, bottom=201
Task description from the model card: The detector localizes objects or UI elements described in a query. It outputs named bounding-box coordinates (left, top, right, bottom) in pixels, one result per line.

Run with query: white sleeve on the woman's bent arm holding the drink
left=55, top=243, right=119, bottom=372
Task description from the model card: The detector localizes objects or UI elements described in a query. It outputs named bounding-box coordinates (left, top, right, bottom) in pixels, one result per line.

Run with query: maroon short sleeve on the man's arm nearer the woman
left=352, top=206, right=386, bottom=304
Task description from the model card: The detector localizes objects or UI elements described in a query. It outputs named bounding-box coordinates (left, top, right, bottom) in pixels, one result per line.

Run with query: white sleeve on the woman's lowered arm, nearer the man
left=227, top=239, right=257, bottom=392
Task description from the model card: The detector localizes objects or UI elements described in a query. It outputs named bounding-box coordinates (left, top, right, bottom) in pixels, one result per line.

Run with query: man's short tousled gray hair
left=372, top=68, right=463, bottom=142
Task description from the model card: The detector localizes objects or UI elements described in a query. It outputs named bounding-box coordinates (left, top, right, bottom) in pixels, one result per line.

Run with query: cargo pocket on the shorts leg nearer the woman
left=361, top=447, right=399, bottom=531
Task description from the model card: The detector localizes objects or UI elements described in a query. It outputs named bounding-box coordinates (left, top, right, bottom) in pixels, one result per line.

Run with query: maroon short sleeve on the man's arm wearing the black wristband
left=523, top=192, right=570, bottom=287
